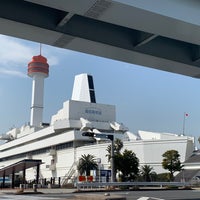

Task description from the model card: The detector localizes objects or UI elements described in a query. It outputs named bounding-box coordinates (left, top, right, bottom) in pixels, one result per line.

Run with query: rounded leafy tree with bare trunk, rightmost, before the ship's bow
left=162, top=150, right=182, bottom=181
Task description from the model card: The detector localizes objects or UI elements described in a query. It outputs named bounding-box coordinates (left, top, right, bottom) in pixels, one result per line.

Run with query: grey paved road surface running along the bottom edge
left=0, top=190, right=200, bottom=200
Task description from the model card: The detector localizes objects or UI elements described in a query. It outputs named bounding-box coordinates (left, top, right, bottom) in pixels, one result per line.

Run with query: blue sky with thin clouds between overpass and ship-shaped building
left=0, top=35, right=200, bottom=146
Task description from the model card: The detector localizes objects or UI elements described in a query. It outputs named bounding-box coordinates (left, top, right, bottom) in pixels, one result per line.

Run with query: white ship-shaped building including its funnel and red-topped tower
left=0, top=55, right=194, bottom=184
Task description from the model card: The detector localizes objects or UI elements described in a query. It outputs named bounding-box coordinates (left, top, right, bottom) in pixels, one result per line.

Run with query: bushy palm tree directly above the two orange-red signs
left=77, top=154, right=98, bottom=176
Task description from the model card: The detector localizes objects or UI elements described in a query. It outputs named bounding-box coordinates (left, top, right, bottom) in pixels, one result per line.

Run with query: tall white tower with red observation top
left=28, top=55, right=49, bottom=127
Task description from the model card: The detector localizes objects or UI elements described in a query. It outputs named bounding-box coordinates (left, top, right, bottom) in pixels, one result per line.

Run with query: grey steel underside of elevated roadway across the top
left=0, top=0, right=200, bottom=78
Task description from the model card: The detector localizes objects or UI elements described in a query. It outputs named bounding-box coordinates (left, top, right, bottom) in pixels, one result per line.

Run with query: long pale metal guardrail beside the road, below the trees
left=75, top=182, right=190, bottom=189
